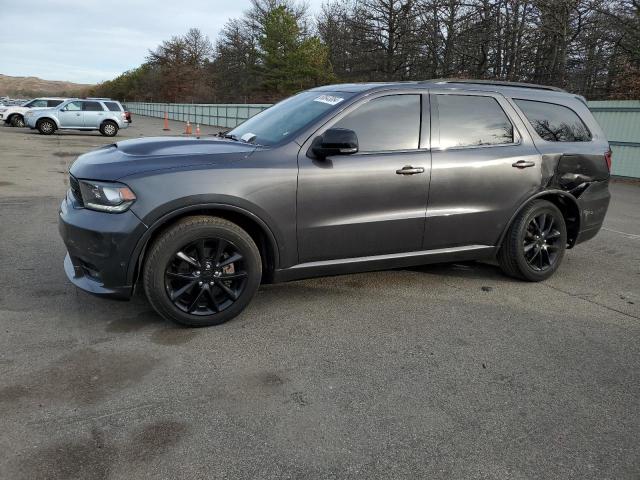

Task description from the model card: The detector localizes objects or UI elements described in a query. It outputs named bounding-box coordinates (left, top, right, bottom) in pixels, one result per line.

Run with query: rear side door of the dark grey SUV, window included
left=424, top=90, right=541, bottom=249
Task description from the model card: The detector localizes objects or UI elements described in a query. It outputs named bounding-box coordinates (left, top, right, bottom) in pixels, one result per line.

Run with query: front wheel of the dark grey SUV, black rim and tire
left=143, top=216, right=262, bottom=327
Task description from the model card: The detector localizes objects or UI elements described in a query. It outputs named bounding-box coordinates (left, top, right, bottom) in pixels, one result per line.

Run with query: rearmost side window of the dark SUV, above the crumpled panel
left=514, top=100, right=591, bottom=142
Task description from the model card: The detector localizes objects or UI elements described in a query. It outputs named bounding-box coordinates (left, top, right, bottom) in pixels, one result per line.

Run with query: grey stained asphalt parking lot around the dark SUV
left=0, top=117, right=640, bottom=480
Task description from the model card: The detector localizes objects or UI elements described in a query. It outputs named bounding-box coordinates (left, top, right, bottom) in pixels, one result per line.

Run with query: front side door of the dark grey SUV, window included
left=298, top=93, right=431, bottom=263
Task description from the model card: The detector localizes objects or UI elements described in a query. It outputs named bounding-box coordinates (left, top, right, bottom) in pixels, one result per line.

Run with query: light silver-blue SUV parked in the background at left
left=24, top=98, right=129, bottom=137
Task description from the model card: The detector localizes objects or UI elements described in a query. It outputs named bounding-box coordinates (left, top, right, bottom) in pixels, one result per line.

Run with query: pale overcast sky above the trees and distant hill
left=0, top=0, right=322, bottom=83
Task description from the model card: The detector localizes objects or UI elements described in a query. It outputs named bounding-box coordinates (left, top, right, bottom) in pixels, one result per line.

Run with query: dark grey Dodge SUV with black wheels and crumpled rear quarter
left=60, top=81, right=611, bottom=325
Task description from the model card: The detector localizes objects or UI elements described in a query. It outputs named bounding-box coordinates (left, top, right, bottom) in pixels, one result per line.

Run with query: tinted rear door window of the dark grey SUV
left=435, top=95, right=513, bottom=148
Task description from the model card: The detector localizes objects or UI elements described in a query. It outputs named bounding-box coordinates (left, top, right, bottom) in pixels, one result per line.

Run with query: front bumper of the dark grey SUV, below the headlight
left=58, top=191, right=147, bottom=299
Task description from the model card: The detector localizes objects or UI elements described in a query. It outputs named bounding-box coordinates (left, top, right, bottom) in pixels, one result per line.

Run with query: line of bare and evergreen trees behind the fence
left=91, top=0, right=640, bottom=103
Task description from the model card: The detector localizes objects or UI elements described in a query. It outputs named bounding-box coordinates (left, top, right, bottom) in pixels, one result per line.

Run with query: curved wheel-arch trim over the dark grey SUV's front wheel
left=127, top=203, right=280, bottom=285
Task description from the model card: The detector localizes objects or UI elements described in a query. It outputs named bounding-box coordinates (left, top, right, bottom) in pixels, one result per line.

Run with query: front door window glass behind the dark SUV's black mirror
left=334, top=95, right=420, bottom=152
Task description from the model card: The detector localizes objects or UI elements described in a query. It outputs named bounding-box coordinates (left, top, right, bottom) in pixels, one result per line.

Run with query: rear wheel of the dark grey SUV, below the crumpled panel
left=498, top=200, right=567, bottom=282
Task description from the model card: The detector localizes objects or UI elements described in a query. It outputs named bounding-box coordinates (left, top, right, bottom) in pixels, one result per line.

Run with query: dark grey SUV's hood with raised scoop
left=69, top=137, right=257, bottom=181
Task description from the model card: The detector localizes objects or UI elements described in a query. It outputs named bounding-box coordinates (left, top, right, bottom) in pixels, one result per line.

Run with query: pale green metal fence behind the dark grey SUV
left=127, top=100, right=640, bottom=178
